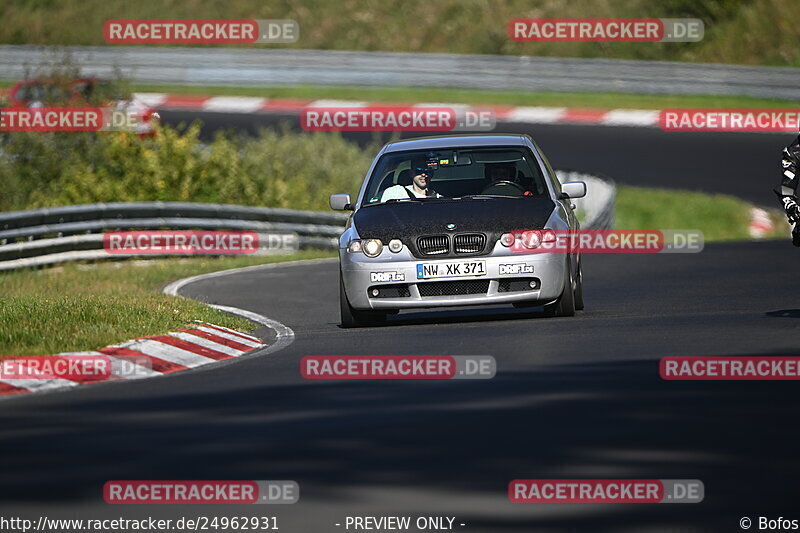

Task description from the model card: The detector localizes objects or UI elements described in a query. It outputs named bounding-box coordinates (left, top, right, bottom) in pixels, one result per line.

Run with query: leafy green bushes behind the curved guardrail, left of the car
left=0, top=124, right=374, bottom=211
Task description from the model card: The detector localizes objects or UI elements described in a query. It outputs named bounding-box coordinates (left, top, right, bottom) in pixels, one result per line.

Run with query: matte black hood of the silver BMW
left=353, top=197, right=556, bottom=244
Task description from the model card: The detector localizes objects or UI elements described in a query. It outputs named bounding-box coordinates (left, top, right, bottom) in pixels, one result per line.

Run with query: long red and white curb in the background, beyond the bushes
left=134, top=93, right=660, bottom=127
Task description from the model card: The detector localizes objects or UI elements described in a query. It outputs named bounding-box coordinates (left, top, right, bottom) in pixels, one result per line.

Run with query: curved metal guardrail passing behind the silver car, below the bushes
left=0, top=171, right=615, bottom=271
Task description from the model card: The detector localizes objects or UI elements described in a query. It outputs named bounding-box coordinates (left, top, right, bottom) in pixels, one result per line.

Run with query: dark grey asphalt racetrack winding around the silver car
left=0, top=117, right=800, bottom=533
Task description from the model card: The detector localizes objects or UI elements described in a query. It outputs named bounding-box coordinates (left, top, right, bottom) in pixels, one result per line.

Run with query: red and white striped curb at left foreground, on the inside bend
left=0, top=322, right=267, bottom=396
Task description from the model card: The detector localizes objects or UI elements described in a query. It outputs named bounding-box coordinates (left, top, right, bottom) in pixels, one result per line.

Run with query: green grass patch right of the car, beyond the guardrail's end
left=616, top=186, right=788, bottom=242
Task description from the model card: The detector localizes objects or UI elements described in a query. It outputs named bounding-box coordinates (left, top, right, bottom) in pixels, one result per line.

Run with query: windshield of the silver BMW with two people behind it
left=362, top=147, right=548, bottom=206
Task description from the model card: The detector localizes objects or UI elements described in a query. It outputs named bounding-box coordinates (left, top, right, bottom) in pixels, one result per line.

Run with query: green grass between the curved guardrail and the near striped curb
left=0, top=251, right=333, bottom=355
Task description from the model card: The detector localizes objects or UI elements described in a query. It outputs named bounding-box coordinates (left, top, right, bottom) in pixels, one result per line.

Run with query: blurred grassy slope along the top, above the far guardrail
left=0, top=0, right=800, bottom=66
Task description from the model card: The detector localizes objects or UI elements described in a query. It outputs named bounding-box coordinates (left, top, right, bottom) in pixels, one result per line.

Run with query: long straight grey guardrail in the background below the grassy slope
left=0, top=45, right=800, bottom=99
